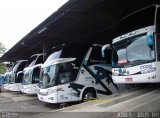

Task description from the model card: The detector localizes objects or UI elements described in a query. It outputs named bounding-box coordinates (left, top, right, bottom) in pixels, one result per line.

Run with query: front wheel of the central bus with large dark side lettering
left=82, top=90, right=96, bottom=101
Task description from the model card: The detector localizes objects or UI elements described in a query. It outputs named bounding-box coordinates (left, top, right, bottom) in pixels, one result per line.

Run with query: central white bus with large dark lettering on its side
left=37, top=44, right=125, bottom=103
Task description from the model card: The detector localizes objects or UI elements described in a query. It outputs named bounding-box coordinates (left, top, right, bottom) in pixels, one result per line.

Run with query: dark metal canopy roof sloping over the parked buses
left=0, top=0, right=160, bottom=61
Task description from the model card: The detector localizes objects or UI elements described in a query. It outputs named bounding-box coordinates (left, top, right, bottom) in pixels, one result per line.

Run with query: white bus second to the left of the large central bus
left=8, top=60, right=27, bottom=91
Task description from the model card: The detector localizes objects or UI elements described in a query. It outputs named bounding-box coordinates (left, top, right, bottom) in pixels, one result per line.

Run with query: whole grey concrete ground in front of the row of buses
left=0, top=85, right=160, bottom=118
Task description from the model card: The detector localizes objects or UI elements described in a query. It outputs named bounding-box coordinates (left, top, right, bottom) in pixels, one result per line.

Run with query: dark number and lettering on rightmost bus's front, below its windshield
left=140, top=64, right=156, bottom=74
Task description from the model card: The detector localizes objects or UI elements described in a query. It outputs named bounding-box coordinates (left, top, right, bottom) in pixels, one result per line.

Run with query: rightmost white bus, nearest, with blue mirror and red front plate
left=112, top=5, right=160, bottom=84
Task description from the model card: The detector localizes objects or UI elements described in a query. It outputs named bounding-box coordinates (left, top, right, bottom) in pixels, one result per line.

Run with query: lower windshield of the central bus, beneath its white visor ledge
left=39, top=61, right=77, bottom=88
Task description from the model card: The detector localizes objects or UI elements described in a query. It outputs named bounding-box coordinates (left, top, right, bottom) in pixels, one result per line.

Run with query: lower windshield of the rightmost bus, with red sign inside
left=113, top=34, right=155, bottom=66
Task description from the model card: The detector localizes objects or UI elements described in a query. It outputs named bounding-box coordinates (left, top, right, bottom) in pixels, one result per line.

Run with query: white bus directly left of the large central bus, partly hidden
left=21, top=54, right=43, bottom=94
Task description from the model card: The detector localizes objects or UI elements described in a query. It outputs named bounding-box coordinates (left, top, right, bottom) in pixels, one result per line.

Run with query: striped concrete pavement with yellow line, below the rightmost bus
left=32, top=87, right=160, bottom=118
